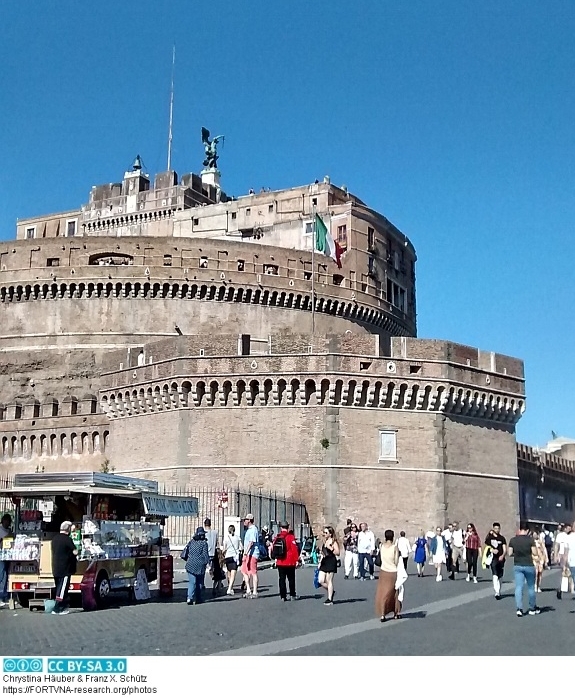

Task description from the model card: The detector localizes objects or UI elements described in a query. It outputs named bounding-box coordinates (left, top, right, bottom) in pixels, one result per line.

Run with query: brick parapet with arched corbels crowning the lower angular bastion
left=100, top=335, right=524, bottom=424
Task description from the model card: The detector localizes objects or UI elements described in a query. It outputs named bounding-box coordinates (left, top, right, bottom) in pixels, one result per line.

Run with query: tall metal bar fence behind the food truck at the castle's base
left=0, top=475, right=311, bottom=549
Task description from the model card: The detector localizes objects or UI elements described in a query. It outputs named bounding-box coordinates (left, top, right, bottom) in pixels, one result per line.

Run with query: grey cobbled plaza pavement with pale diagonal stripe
left=0, top=565, right=575, bottom=656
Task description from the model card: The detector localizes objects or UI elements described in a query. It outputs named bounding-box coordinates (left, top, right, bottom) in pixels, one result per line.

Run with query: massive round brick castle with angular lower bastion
left=0, top=151, right=524, bottom=534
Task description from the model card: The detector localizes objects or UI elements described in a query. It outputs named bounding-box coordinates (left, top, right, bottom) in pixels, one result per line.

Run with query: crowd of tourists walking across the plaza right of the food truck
left=181, top=514, right=575, bottom=622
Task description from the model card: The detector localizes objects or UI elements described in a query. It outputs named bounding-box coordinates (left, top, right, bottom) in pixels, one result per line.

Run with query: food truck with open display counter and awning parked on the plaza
left=0, top=472, right=198, bottom=610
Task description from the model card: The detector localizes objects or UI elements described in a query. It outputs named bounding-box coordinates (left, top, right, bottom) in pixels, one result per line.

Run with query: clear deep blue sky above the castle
left=0, top=0, right=575, bottom=445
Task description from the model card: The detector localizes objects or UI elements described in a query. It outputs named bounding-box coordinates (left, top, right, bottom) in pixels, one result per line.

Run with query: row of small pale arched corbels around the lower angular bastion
left=100, top=375, right=524, bottom=424
